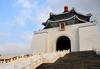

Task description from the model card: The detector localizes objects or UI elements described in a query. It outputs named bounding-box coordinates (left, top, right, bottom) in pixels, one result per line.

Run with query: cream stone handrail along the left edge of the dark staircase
left=21, top=50, right=69, bottom=69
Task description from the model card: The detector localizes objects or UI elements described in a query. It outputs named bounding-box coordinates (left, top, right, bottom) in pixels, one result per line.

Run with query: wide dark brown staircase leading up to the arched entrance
left=36, top=51, right=100, bottom=69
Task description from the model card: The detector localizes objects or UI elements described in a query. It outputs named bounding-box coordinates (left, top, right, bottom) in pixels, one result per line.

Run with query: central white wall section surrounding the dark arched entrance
left=50, top=25, right=79, bottom=51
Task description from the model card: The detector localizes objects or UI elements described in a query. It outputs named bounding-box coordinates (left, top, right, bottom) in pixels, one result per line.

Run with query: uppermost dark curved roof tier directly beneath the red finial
left=48, top=8, right=92, bottom=21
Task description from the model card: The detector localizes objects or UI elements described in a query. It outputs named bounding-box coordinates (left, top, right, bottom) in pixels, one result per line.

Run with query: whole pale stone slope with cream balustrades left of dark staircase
left=0, top=50, right=69, bottom=69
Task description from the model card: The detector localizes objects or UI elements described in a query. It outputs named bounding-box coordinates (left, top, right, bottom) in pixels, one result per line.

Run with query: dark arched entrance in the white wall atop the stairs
left=56, top=36, right=71, bottom=51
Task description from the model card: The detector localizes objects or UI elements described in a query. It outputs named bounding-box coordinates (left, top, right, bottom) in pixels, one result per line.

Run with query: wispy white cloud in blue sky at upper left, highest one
left=13, top=0, right=37, bottom=26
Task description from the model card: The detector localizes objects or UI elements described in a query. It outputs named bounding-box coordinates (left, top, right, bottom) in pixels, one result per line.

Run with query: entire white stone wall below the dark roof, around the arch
left=30, top=23, right=100, bottom=53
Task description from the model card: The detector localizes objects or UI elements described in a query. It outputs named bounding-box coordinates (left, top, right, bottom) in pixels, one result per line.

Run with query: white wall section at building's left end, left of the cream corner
left=29, top=33, right=47, bottom=53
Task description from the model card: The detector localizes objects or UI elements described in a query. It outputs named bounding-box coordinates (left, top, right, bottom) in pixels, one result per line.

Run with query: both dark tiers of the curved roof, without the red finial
left=42, top=8, right=92, bottom=29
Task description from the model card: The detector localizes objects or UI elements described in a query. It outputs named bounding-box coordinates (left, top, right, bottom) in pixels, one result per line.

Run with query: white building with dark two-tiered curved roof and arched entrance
left=29, top=8, right=100, bottom=53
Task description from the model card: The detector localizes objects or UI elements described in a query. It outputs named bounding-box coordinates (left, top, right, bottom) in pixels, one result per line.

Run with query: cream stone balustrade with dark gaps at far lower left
left=0, top=54, right=35, bottom=64
